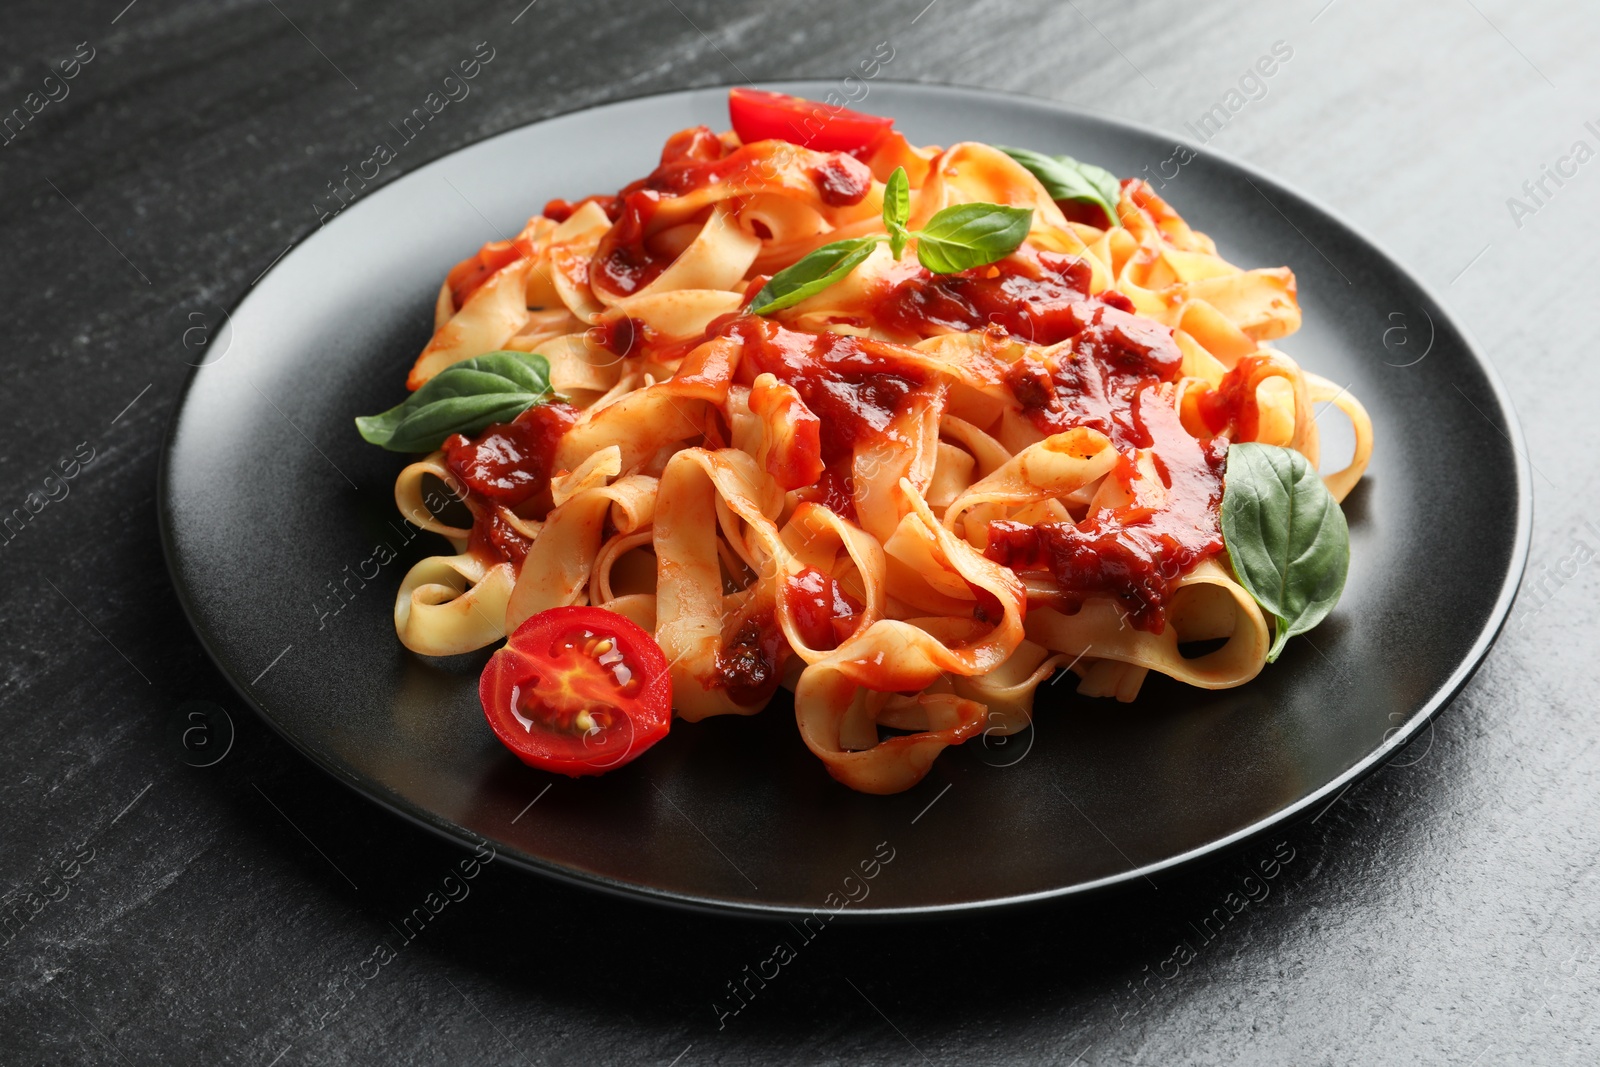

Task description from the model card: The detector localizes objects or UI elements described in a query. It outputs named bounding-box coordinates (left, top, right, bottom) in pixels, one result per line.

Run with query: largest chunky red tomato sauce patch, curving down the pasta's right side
left=875, top=255, right=1237, bottom=633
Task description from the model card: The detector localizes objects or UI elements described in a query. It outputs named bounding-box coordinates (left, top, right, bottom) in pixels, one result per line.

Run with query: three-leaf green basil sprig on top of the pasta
left=750, top=166, right=1034, bottom=315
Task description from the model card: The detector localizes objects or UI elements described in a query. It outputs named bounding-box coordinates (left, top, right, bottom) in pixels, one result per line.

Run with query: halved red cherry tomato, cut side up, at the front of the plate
left=478, top=608, right=672, bottom=777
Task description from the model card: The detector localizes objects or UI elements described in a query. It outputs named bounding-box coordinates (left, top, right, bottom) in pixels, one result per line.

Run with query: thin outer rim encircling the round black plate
left=155, top=78, right=1533, bottom=925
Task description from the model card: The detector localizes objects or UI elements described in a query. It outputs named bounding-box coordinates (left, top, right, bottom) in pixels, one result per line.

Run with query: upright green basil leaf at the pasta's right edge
left=1222, top=443, right=1350, bottom=664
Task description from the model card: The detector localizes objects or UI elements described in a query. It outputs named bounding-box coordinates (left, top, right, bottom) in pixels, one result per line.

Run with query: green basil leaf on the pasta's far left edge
left=355, top=352, right=555, bottom=453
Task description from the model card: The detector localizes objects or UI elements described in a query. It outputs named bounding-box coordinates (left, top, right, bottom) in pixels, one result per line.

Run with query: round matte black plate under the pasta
left=160, top=83, right=1531, bottom=915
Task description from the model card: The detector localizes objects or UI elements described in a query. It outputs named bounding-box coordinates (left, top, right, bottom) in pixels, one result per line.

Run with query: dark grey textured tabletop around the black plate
left=0, top=0, right=1600, bottom=1067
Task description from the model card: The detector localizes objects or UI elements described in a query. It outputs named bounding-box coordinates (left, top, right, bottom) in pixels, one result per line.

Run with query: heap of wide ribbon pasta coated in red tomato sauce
left=368, top=89, right=1373, bottom=793
